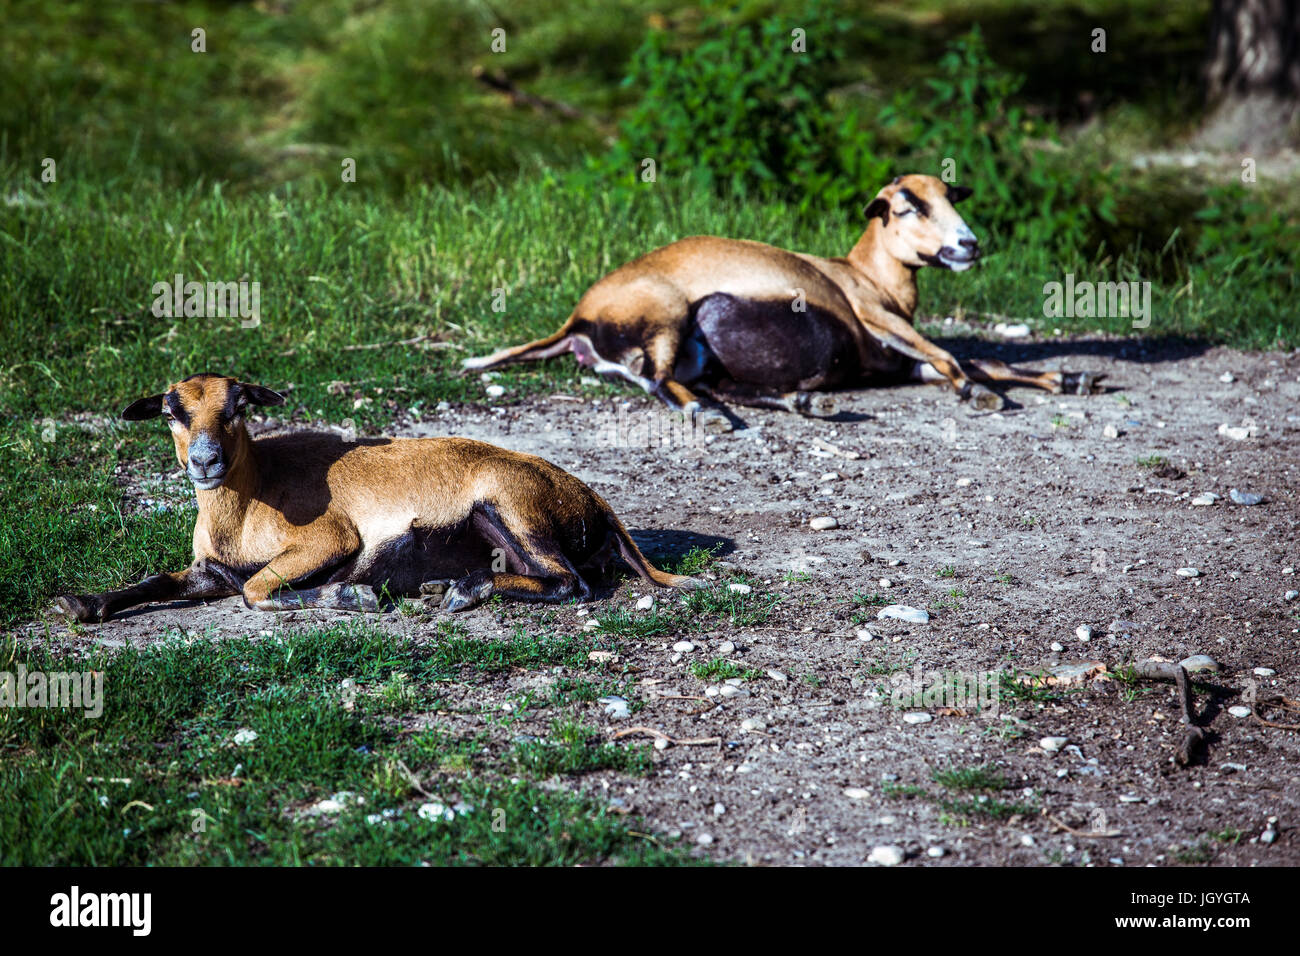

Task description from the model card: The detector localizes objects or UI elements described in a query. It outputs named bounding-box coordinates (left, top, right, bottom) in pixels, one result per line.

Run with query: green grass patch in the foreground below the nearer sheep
left=0, top=624, right=685, bottom=866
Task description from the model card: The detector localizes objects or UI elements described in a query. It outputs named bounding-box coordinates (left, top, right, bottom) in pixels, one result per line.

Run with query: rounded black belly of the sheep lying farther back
left=688, top=293, right=906, bottom=392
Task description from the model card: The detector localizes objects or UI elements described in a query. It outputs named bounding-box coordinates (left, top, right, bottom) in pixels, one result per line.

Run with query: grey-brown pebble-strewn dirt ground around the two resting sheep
left=27, top=339, right=1300, bottom=865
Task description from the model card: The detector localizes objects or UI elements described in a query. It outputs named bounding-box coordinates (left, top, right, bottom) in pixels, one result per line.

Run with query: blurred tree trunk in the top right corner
left=1199, top=0, right=1300, bottom=152
